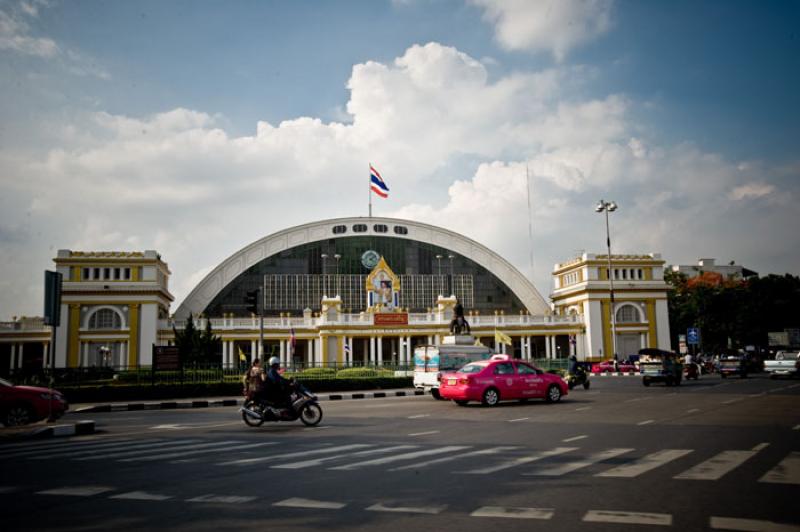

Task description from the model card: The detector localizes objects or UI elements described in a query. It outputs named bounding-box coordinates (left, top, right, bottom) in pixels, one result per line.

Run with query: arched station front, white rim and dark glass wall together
left=175, top=218, right=549, bottom=319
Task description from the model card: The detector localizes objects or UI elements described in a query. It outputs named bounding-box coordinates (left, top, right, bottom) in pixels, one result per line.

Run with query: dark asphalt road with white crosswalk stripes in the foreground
left=0, top=376, right=800, bottom=532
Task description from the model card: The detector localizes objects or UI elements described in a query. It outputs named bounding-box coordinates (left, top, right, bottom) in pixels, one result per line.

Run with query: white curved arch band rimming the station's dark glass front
left=175, top=217, right=549, bottom=319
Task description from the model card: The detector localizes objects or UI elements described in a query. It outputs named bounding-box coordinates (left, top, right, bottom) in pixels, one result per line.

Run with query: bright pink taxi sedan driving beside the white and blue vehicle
left=439, top=355, right=567, bottom=406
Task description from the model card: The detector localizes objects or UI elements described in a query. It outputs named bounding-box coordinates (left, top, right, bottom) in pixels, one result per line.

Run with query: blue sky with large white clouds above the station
left=0, top=0, right=800, bottom=320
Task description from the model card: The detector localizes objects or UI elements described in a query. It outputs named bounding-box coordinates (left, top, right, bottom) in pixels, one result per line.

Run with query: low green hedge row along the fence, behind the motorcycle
left=59, top=376, right=413, bottom=404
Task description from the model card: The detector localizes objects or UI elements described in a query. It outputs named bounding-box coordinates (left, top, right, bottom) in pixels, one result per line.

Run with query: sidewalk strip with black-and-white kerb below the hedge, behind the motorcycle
left=68, top=388, right=424, bottom=414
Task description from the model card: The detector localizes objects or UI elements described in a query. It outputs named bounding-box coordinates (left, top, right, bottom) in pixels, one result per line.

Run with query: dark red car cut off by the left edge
left=0, top=379, right=69, bottom=427
